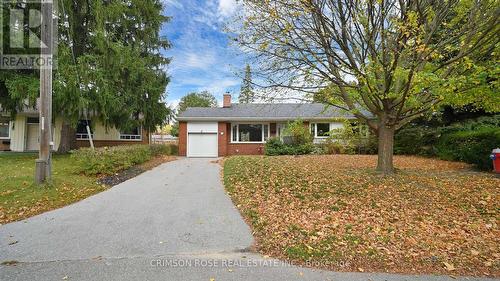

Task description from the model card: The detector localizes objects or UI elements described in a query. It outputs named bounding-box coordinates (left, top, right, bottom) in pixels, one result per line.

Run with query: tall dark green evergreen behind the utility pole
left=0, top=0, right=170, bottom=152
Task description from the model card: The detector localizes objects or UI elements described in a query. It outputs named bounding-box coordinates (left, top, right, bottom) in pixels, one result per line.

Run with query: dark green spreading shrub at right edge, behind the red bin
left=436, top=127, right=500, bottom=170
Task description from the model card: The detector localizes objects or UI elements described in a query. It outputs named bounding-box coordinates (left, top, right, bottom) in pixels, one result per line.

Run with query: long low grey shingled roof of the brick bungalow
left=177, top=103, right=355, bottom=121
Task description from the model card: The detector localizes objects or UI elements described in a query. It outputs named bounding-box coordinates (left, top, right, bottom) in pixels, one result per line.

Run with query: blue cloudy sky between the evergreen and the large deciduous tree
left=161, top=0, right=245, bottom=106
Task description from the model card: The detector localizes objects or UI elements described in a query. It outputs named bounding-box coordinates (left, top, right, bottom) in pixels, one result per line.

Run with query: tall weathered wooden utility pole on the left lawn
left=35, top=0, right=54, bottom=184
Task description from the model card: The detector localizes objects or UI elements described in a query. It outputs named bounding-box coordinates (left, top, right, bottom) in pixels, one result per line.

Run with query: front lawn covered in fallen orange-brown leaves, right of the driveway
left=224, top=155, right=500, bottom=276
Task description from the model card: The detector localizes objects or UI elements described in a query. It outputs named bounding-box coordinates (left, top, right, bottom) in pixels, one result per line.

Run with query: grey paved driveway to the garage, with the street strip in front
left=0, top=159, right=496, bottom=281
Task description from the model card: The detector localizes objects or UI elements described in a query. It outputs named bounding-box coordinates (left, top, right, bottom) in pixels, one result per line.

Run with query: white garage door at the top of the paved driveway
left=187, top=122, right=218, bottom=157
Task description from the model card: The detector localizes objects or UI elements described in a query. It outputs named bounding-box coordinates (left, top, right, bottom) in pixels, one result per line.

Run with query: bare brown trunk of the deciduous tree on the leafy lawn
left=377, top=125, right=395, bottom=175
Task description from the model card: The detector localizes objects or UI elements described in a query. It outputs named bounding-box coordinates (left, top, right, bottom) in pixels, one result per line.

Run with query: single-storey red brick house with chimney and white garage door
left=177, top=94, right=366, bottom=157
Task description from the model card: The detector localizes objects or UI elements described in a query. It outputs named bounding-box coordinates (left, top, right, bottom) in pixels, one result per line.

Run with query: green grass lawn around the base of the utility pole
left=0, top=152, right=108, bottom=224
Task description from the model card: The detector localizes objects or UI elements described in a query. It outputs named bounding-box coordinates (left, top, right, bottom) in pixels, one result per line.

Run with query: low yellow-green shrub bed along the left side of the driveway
left=71, top=144, right=177, bottom=175
